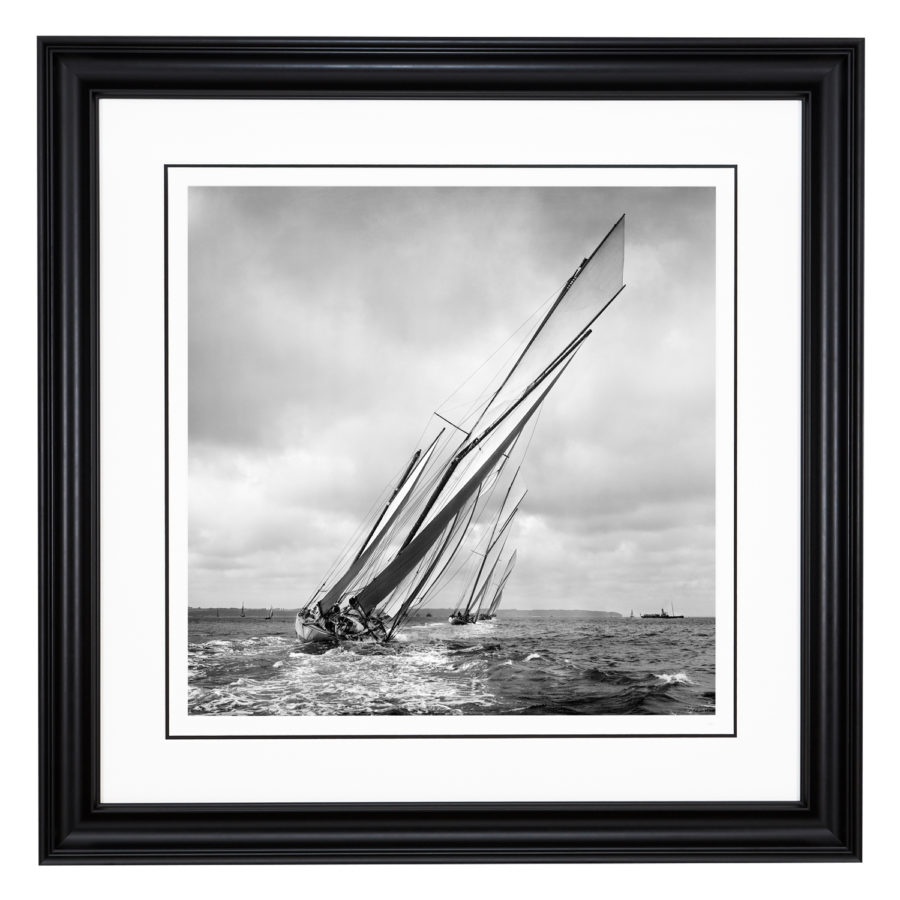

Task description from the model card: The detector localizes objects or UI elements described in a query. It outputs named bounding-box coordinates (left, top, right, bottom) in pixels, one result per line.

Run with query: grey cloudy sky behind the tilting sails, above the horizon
left=189, top=187, right=715, bottom=615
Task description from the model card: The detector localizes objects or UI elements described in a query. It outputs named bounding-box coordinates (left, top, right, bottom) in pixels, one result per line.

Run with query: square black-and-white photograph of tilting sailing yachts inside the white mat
left=179, top=179, right=733, bottom=717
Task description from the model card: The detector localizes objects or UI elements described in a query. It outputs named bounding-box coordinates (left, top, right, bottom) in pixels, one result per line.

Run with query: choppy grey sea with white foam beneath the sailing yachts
left=187, top=611, right=715, bottom=716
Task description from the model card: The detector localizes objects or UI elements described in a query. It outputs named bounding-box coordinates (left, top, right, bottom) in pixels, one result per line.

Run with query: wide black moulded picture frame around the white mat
left=38, top=37, right=864, bottom=864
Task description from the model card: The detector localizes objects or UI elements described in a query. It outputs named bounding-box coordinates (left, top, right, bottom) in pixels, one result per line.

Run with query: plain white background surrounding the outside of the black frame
left=0, top=0, right=900, bottom=900
